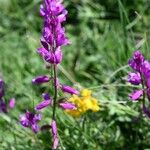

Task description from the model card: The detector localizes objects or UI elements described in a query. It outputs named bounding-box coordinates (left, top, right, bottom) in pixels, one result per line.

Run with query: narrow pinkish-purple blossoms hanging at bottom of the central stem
left=51, top=120, right=59, bottom=150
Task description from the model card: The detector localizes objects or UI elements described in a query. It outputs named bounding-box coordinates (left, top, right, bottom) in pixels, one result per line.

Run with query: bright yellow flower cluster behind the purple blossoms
left=66, top=89, right=100, bottom=117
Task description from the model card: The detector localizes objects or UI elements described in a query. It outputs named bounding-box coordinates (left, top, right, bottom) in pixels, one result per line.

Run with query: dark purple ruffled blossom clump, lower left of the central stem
left=20, top=111, right=41, bottom=133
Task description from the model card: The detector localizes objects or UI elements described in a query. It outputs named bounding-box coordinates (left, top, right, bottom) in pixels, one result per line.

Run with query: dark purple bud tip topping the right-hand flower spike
left=128, top=50, right=144, bottom=71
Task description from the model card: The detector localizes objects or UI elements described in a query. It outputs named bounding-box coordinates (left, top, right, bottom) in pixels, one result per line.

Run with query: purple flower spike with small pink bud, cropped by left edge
left=0, top=79, right=15, bottom=113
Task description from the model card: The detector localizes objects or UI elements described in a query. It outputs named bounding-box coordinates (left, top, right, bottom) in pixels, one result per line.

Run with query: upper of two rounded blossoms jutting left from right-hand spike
left=128, top=73, right=141, bottom=85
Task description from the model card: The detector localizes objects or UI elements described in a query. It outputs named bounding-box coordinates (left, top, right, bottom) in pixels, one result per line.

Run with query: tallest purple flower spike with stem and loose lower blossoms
left=20, top=0, right=79, bottom=149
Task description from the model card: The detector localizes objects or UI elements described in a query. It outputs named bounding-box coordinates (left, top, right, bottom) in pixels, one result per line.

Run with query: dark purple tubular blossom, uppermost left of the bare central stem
left=32, top=76, right=50, bottom=84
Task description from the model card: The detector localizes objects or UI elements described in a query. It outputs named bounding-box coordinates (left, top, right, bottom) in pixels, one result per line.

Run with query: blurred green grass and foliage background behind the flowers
left=0, top=0, right=150, bottom=150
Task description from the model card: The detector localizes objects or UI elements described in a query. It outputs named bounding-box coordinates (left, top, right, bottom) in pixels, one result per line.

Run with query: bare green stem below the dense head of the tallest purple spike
left=53, top=65, right=57, bottom=120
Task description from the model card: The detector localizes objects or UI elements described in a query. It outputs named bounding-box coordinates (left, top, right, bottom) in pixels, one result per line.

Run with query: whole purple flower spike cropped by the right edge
left=128, top=51, right=150, bottom=117
